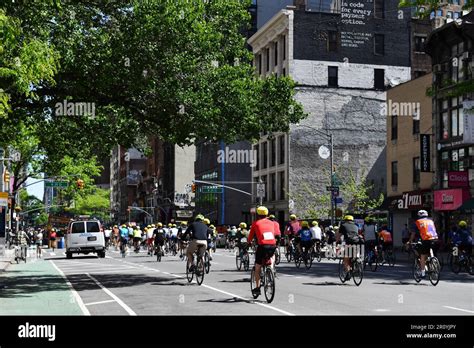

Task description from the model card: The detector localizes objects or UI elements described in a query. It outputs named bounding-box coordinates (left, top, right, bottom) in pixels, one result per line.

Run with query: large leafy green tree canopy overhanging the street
left=2, top=0, right=304, bottom=155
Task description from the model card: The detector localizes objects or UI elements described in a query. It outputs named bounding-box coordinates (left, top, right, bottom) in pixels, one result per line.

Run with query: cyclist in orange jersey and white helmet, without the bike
left=409, top=210, right=438, bottom=278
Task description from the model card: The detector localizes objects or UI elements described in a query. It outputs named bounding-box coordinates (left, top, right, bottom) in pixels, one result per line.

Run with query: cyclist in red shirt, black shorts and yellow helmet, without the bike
left=248, top=206, right=276, bottom=295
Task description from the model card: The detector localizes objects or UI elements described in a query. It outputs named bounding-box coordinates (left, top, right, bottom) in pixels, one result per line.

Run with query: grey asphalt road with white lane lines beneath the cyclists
left=0, top=249, right=474, bottom=315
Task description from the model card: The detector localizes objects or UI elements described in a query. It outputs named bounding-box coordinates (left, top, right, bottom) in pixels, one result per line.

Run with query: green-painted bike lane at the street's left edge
left=0, top=253, right=83, bottom=315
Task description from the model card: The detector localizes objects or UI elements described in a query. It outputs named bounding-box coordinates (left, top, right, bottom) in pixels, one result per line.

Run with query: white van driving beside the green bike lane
left=66, top=220, right=105, bottom=259
